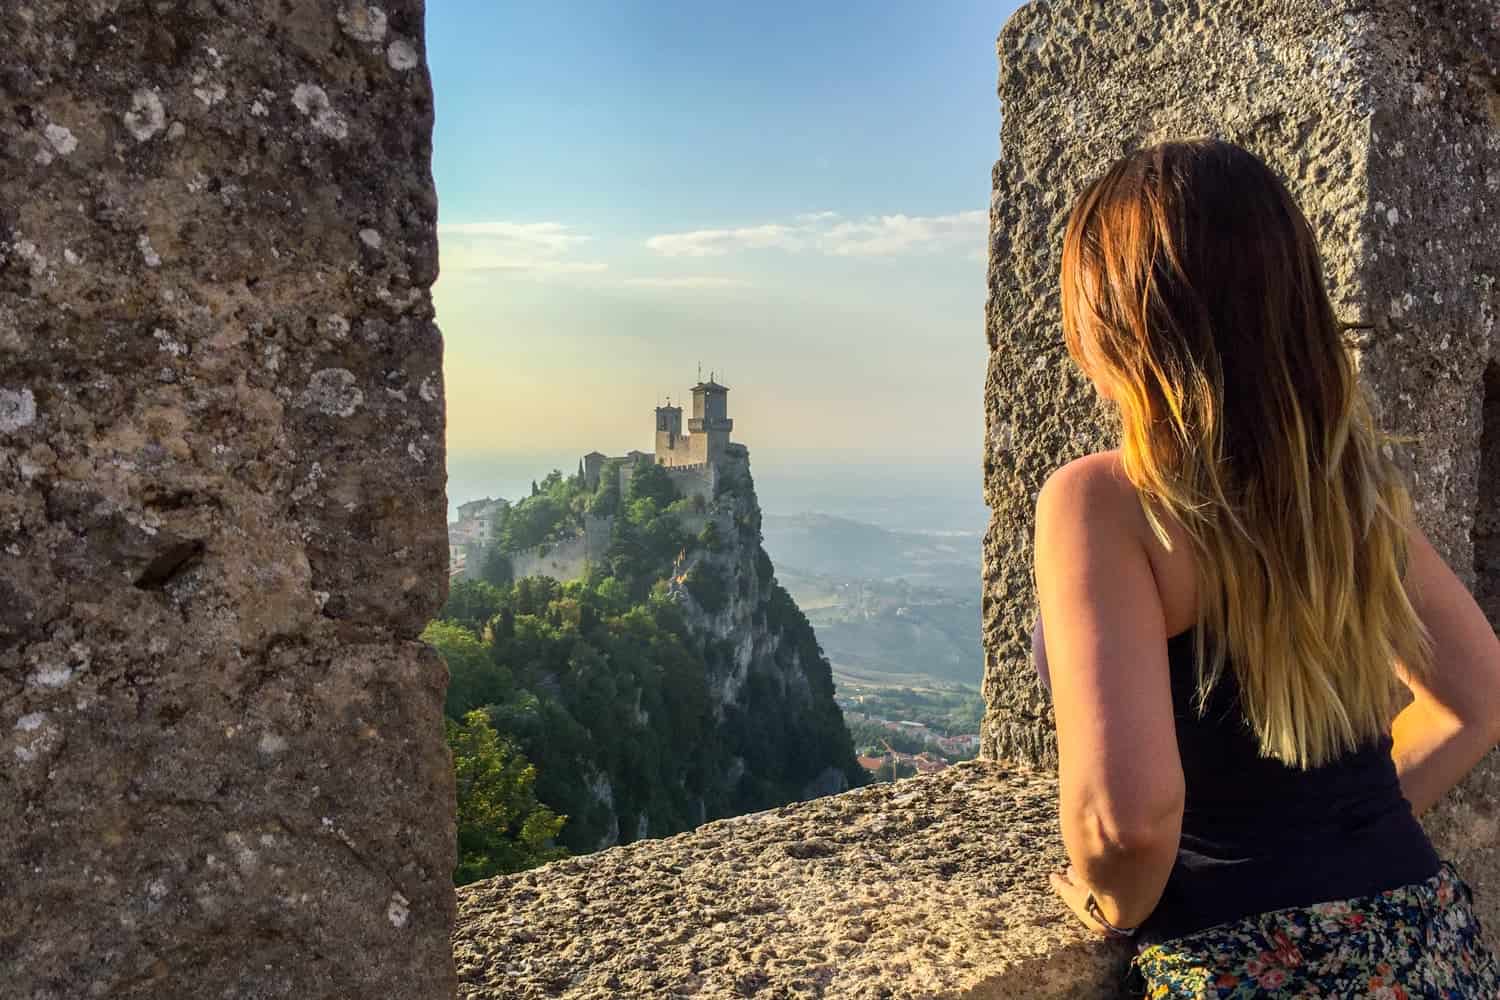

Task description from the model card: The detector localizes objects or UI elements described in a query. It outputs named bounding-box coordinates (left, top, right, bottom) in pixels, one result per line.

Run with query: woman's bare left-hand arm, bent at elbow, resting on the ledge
left=1035, top=454, right=1184, bottom=927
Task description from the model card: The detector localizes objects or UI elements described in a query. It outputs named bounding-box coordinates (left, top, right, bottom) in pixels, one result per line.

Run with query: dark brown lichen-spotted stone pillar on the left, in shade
left=0, top=0, right=453, bottom=1000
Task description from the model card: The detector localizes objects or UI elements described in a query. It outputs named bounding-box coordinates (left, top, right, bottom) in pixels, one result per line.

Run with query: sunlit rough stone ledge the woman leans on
left=453, top=762, right=1128, bottom=1000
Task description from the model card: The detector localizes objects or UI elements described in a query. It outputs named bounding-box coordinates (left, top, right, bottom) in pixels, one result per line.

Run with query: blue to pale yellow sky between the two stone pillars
left=428, top=0, right=1017, bottom=515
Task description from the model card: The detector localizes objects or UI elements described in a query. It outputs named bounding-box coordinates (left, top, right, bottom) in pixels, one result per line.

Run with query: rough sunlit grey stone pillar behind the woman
left=983, top=0, right=1500, bottom=928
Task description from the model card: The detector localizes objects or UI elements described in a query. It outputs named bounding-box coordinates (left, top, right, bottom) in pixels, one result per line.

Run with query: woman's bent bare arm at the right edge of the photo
left=1391, top=528, right=1500, bottom=816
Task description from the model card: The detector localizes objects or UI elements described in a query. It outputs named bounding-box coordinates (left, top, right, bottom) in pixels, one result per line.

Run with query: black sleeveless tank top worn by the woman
left=1034, top=622, right=1440, bottom=946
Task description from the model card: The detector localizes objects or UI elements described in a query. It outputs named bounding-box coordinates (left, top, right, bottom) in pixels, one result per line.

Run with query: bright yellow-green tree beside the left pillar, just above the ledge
left=447, top=711, right=567, bottom=886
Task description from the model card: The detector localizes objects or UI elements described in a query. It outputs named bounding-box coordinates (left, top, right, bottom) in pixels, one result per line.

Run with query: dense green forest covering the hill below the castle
left=423, top=463, right=864, bottom=883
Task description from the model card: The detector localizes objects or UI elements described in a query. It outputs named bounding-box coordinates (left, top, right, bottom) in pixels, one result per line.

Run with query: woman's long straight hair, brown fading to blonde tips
left=1062, top=139, right=1431, bottom=768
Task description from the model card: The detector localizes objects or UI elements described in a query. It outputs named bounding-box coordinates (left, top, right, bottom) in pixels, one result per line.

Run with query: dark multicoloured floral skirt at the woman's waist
left=1133, top=861, right=1500, bottom=1000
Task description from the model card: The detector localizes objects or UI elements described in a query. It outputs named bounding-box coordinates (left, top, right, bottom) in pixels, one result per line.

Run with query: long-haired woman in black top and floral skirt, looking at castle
left=1035, top=141, right=1500, bottom=1000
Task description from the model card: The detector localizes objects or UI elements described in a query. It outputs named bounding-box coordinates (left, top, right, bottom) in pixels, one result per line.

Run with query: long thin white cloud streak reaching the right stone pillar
left=647, top=210, right=989, bottom=256
